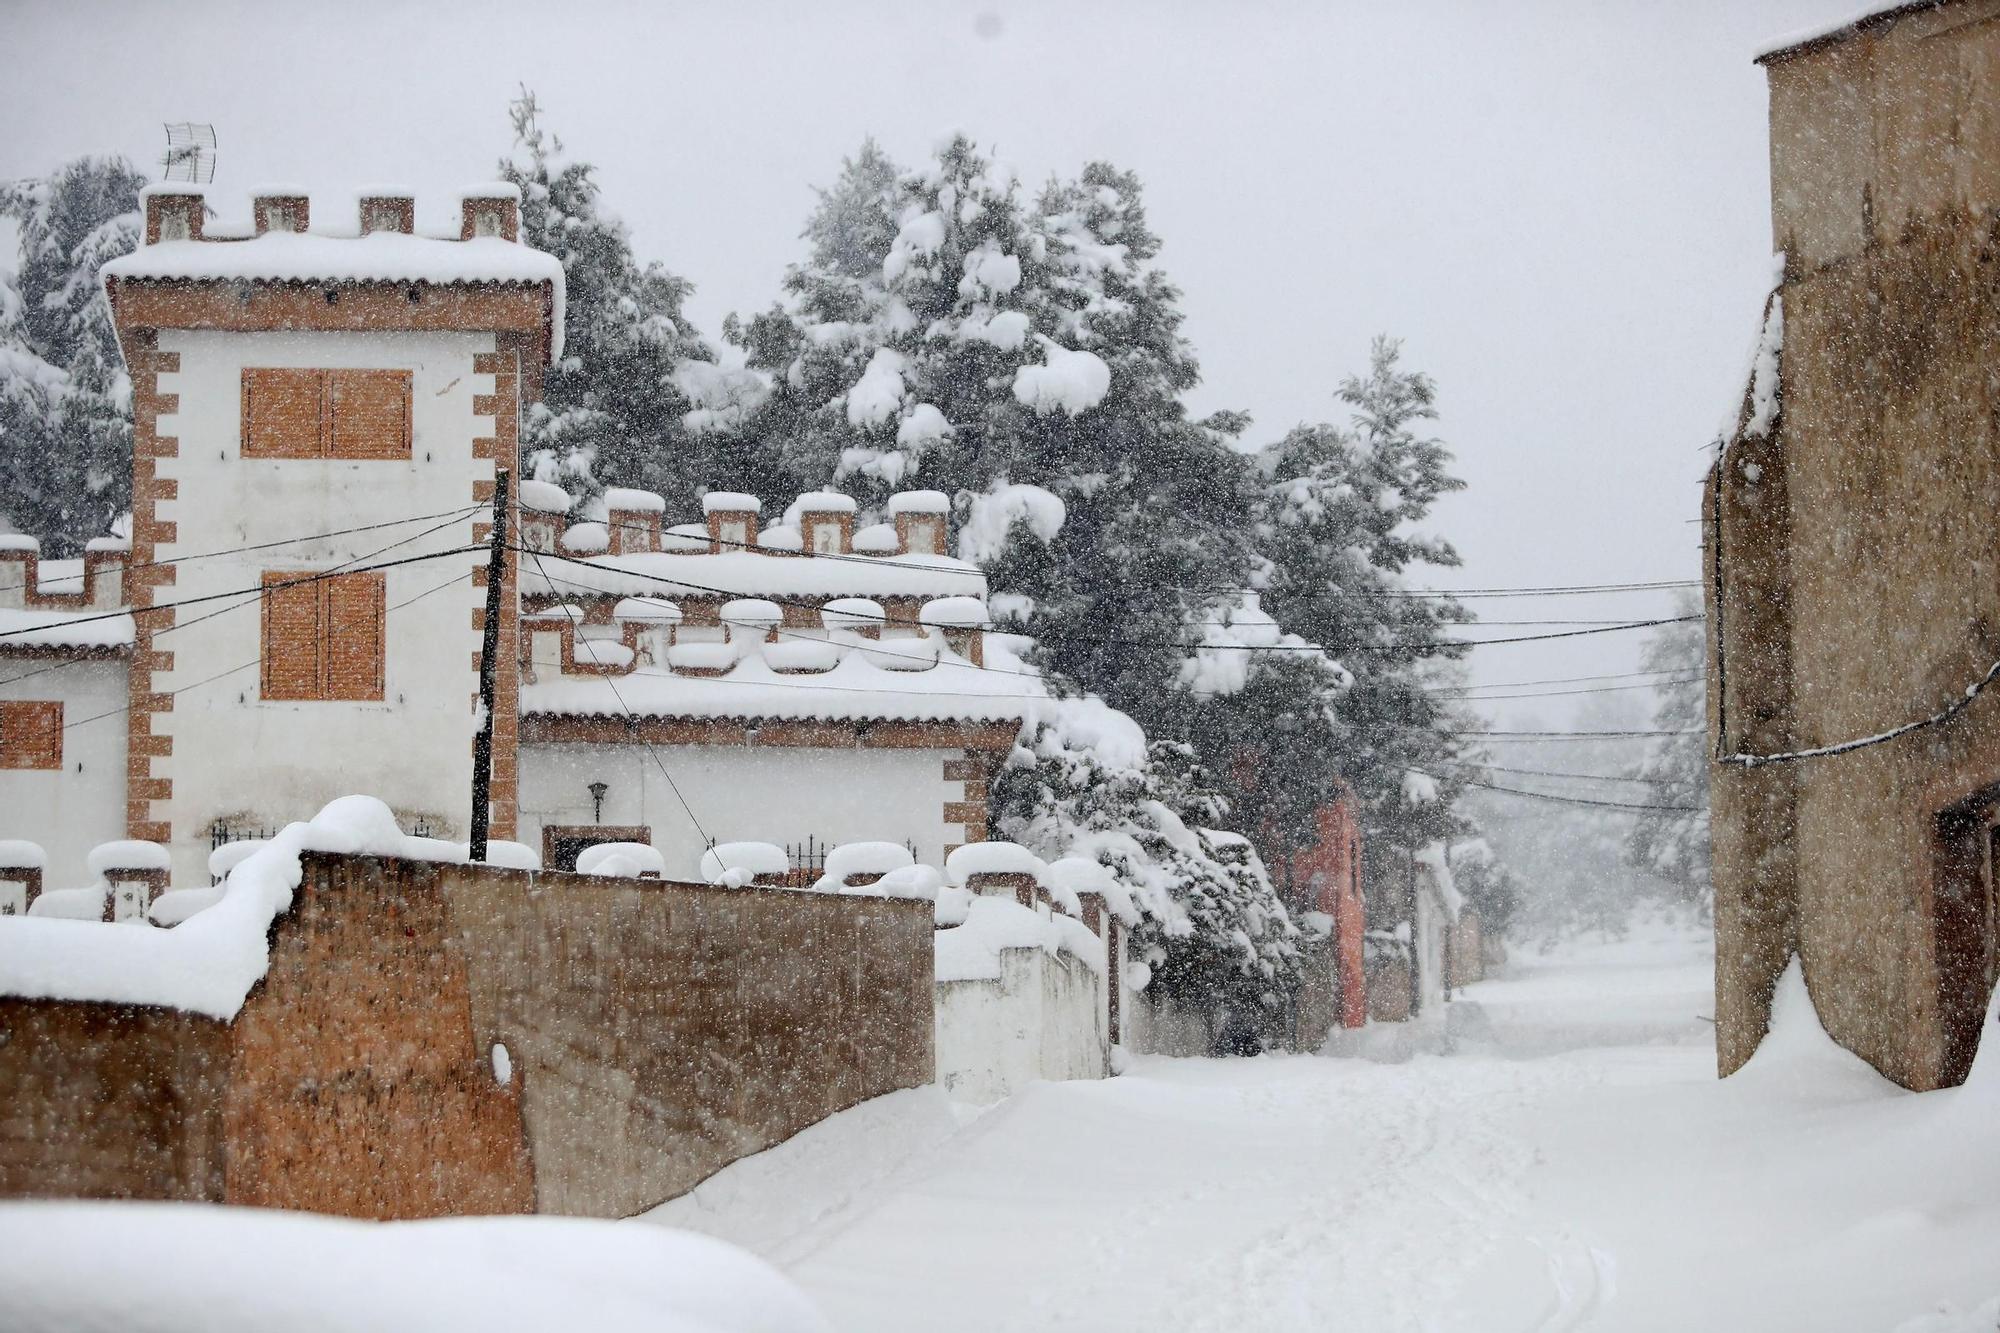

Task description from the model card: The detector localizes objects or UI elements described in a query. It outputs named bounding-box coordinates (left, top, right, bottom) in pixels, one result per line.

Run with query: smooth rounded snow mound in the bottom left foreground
left=0, top=1203, right=830, bottom=1333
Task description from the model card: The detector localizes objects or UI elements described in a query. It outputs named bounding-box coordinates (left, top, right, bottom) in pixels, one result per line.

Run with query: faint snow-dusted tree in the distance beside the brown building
left=1626, top=594, right=1714, bottom=907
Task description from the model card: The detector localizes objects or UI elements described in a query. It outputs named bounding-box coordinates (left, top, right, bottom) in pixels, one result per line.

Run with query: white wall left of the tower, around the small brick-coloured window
left=0, top=658, right=126, bottom=889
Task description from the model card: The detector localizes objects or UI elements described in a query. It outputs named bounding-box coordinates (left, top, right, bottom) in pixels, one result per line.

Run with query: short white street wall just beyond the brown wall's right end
left=936, top=932, right=1110, bottom=1103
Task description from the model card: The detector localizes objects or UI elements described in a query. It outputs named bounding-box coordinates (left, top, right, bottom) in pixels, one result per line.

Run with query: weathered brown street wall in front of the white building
left=0, top=855, right=932, bottom=1219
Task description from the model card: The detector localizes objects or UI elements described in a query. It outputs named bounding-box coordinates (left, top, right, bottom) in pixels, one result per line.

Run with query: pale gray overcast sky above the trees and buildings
left=0, top=0, right=1854, bottom=719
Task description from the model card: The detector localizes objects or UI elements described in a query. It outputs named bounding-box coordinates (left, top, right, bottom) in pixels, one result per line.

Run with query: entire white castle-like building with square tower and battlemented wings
left=0, top=186, right=1044, bottom=889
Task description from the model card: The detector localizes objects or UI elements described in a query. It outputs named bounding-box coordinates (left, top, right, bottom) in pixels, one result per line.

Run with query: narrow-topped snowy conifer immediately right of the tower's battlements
left=500, top=90, right=762, bottom=510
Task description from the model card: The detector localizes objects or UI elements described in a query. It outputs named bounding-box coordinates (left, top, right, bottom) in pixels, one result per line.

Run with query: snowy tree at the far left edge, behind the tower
left=0, top=158, right=146, bottom=554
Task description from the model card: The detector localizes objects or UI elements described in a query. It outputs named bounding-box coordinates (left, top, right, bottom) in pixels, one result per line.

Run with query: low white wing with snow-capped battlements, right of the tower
left=520, top=484, right=1044, bottom=877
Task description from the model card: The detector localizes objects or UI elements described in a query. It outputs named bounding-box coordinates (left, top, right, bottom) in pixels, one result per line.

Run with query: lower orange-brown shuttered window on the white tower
left=258, top=570, right=386, bottom=701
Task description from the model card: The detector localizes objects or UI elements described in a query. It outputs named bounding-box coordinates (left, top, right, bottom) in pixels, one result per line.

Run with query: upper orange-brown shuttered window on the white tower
left=242, top=366, right=410, bottom=458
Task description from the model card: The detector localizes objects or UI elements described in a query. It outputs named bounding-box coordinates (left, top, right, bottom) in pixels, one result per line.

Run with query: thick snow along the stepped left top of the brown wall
left=0, top=797, right=524, bottom=1023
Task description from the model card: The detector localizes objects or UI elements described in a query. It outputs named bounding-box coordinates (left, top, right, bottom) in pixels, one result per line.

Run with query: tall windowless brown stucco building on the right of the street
left=1704, top=0, right=2000, bottom=1089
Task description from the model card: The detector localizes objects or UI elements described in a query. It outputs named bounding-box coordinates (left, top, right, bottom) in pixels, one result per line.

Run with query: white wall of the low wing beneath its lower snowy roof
left=520, top=745, right=964, bottom=879
